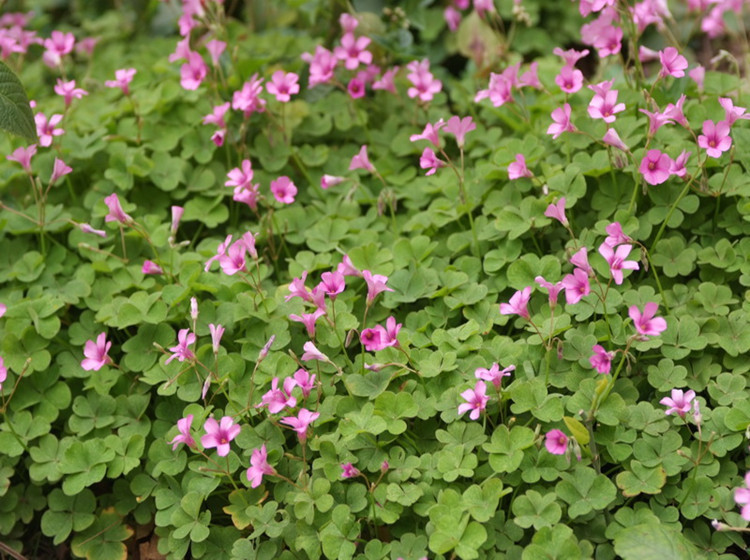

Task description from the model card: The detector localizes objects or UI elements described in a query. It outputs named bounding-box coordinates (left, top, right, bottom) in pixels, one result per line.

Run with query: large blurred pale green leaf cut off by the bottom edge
left=615, top=524, right=705, bottom=560
